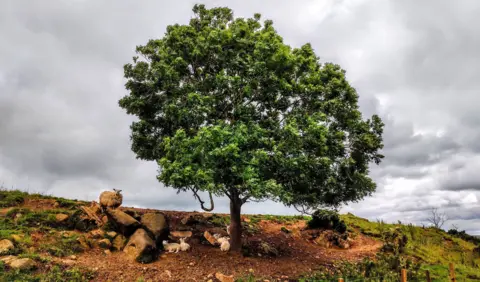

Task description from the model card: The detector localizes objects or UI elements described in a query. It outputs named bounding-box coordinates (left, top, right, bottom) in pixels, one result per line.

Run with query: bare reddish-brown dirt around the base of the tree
left=9, top=199, right=382, bottom=281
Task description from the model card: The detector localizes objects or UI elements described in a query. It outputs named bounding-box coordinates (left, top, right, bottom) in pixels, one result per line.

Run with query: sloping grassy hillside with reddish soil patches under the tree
left=0, top=191, right=480, bottom=281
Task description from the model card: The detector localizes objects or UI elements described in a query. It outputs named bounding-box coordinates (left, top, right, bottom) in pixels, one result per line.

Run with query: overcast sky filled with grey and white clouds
left=0, top=0, right=480, bottom=234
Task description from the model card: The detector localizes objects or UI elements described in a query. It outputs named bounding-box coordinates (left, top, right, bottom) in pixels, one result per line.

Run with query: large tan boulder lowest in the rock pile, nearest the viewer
left=123, top=229, right=156, bottom=263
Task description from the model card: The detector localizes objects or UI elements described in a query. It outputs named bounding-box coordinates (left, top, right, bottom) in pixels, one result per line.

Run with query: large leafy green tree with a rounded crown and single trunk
left=119, top=5, right=383, bottom=251
